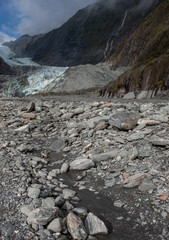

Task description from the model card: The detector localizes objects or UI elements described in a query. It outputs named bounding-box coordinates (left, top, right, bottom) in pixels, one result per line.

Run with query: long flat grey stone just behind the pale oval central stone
left=90, top=150, right=119, bottom=163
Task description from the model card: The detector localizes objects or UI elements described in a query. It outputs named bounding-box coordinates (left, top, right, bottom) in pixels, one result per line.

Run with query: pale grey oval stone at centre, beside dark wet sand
left=70, top=158, right=94, bottom=171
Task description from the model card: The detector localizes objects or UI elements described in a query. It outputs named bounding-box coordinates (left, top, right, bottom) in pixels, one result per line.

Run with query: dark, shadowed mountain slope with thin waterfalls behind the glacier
left=3, top=0, right=153, bottom=66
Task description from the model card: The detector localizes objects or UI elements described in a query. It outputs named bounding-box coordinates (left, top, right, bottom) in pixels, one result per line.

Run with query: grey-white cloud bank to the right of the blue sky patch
left=10, top=0, right=96, bottom=35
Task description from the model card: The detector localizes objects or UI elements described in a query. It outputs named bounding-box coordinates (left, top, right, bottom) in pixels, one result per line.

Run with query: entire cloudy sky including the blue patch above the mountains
left=0, top=0, right=96, bottom=43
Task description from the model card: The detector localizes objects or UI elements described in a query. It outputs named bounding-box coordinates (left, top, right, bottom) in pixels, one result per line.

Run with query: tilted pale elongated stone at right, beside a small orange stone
left=123, top=173, right=147, bottom=188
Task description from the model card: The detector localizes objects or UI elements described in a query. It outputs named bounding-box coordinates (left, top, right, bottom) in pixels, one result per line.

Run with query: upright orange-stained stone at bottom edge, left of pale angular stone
left=67, top=213, right=87, bottom=240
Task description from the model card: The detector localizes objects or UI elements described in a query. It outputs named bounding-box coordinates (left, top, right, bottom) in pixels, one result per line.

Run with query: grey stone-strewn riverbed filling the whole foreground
left=0, top=97, right=169, bottom=240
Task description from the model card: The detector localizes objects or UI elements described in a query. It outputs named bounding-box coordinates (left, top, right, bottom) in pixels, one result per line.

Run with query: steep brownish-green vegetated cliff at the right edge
left=101, top=0, right=169, bottom=95
